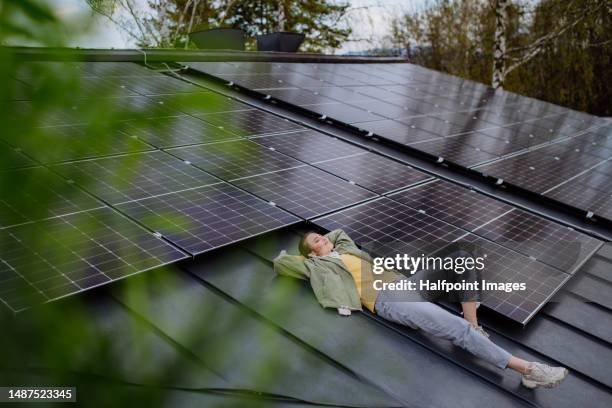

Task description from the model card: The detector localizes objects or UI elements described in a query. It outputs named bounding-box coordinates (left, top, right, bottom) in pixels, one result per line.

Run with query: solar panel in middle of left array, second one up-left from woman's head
left=168, top=140, right=304, bottom=180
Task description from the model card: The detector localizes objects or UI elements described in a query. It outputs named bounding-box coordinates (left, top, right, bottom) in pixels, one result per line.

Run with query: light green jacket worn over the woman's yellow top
left=274, top=230, right=372, bottom=310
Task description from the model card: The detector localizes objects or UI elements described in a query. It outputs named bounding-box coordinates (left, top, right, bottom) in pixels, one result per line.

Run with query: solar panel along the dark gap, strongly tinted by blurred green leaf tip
left=149, top=89, right=252, bottom=115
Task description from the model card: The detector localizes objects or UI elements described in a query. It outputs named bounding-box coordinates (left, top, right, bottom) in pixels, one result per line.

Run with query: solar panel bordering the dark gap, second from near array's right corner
left=390, top=180, right=514, bottom=231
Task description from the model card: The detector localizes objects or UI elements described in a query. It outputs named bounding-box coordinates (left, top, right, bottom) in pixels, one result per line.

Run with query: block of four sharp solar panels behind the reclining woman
left=313, top=191, right=601, bottom=324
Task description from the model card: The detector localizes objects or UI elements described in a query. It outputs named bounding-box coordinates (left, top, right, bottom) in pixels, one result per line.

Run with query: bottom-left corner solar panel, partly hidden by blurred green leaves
left=0, top=207, right=187, bottom=311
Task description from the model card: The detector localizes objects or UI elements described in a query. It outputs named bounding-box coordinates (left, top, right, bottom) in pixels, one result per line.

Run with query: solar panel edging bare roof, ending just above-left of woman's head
left=117, top=183, right=300, bottom=255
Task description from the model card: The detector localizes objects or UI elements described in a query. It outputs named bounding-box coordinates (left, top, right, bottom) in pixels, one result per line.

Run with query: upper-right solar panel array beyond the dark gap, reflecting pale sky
left=184, top=62, right=612, bottom=223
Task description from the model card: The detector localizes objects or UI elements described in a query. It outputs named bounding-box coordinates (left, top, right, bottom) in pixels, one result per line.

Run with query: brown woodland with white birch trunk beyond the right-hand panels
left=391, top=0, right=612, bottom=115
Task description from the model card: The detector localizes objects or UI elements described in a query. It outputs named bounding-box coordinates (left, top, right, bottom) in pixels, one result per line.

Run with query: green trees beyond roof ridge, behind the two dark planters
left=87, top=0, right=351, bottom=51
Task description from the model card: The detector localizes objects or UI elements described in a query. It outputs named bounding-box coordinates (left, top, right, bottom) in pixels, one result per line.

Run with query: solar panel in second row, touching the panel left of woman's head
left=53, top=151, right=220, bottom=204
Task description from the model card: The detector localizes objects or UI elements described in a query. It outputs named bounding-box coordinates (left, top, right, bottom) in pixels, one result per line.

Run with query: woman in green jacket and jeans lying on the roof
left=274, top=230, right=568, bottom=388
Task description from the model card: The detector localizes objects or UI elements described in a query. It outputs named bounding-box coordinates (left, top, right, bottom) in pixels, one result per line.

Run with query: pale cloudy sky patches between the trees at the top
left=50, top=0, right=427, bottom=53
